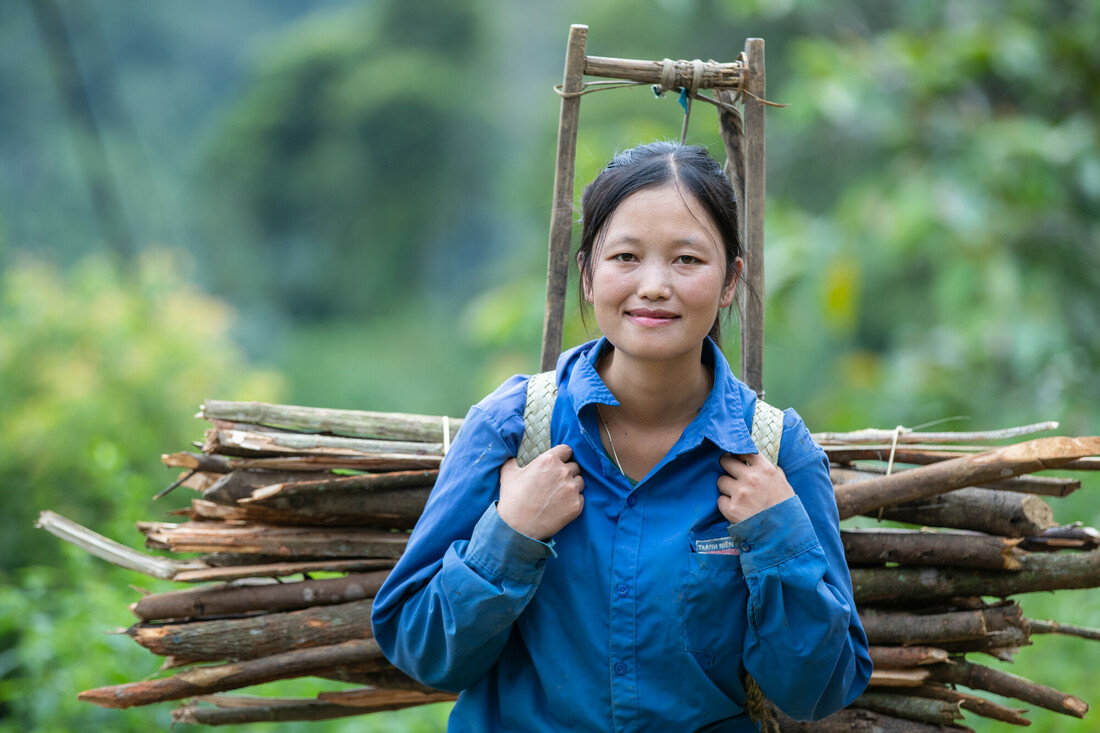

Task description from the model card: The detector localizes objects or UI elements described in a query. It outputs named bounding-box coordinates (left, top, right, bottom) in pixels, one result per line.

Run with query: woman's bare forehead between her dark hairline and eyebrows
left=603, top=184, right=722, bottom=242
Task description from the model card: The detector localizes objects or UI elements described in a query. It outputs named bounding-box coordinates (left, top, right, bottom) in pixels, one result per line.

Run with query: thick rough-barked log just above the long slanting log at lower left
left=127, top=599, right=373, bottom=661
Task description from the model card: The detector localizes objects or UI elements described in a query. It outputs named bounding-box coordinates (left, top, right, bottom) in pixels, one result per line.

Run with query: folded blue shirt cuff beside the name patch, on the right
left=729, top=496, right=821, bottom=575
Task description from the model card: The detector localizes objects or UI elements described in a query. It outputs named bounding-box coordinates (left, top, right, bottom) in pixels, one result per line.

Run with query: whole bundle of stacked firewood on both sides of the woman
left=40, top=401, right=1100, bottom=732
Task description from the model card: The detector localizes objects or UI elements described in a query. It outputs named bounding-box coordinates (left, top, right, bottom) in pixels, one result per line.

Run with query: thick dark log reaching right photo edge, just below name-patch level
left=851, top=550, right=1100, bottom=604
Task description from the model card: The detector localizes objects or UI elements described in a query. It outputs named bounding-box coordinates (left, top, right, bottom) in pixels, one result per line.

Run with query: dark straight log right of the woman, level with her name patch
left=840, top=529, right=1023, bottom=570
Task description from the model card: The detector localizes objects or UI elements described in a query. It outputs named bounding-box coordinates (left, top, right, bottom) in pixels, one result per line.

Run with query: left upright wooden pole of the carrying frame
left=541, top=25, right=589, bottom=371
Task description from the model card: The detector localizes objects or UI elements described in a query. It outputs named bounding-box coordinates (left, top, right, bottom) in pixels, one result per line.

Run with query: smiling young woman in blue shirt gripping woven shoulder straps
left=373, top=143, right=871, bottom=733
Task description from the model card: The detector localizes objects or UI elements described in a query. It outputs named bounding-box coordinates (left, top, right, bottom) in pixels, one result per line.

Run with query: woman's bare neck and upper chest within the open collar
left=596, top=343, right=714, bottom=427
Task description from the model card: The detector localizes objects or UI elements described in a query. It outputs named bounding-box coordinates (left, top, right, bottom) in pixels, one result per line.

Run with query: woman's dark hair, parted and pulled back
left=576, top=142, right=741, bottom=342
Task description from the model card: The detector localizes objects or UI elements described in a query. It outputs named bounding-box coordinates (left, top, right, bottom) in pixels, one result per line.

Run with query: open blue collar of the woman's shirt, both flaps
left=557, top=337, right=757, bottom=455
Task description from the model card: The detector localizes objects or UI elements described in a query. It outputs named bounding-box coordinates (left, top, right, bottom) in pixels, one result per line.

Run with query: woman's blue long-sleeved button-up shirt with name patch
left=373, top=339, right=871, bottom=733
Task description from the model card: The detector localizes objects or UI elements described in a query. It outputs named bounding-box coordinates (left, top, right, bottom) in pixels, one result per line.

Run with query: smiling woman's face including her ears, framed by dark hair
left=582, top=184, right=741, bottom=361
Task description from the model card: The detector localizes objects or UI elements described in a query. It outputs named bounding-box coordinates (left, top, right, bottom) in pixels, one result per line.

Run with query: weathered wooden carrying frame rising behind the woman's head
left=541, top=25, right=766, bottom=395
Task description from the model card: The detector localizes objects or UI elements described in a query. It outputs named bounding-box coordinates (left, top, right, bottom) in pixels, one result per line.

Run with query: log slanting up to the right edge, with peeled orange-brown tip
left=836, top=436, right=1100, bottom=518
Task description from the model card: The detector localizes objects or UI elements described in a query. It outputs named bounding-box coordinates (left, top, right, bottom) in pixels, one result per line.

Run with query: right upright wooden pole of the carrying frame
left=738, top=39, right=767, bottom=396
